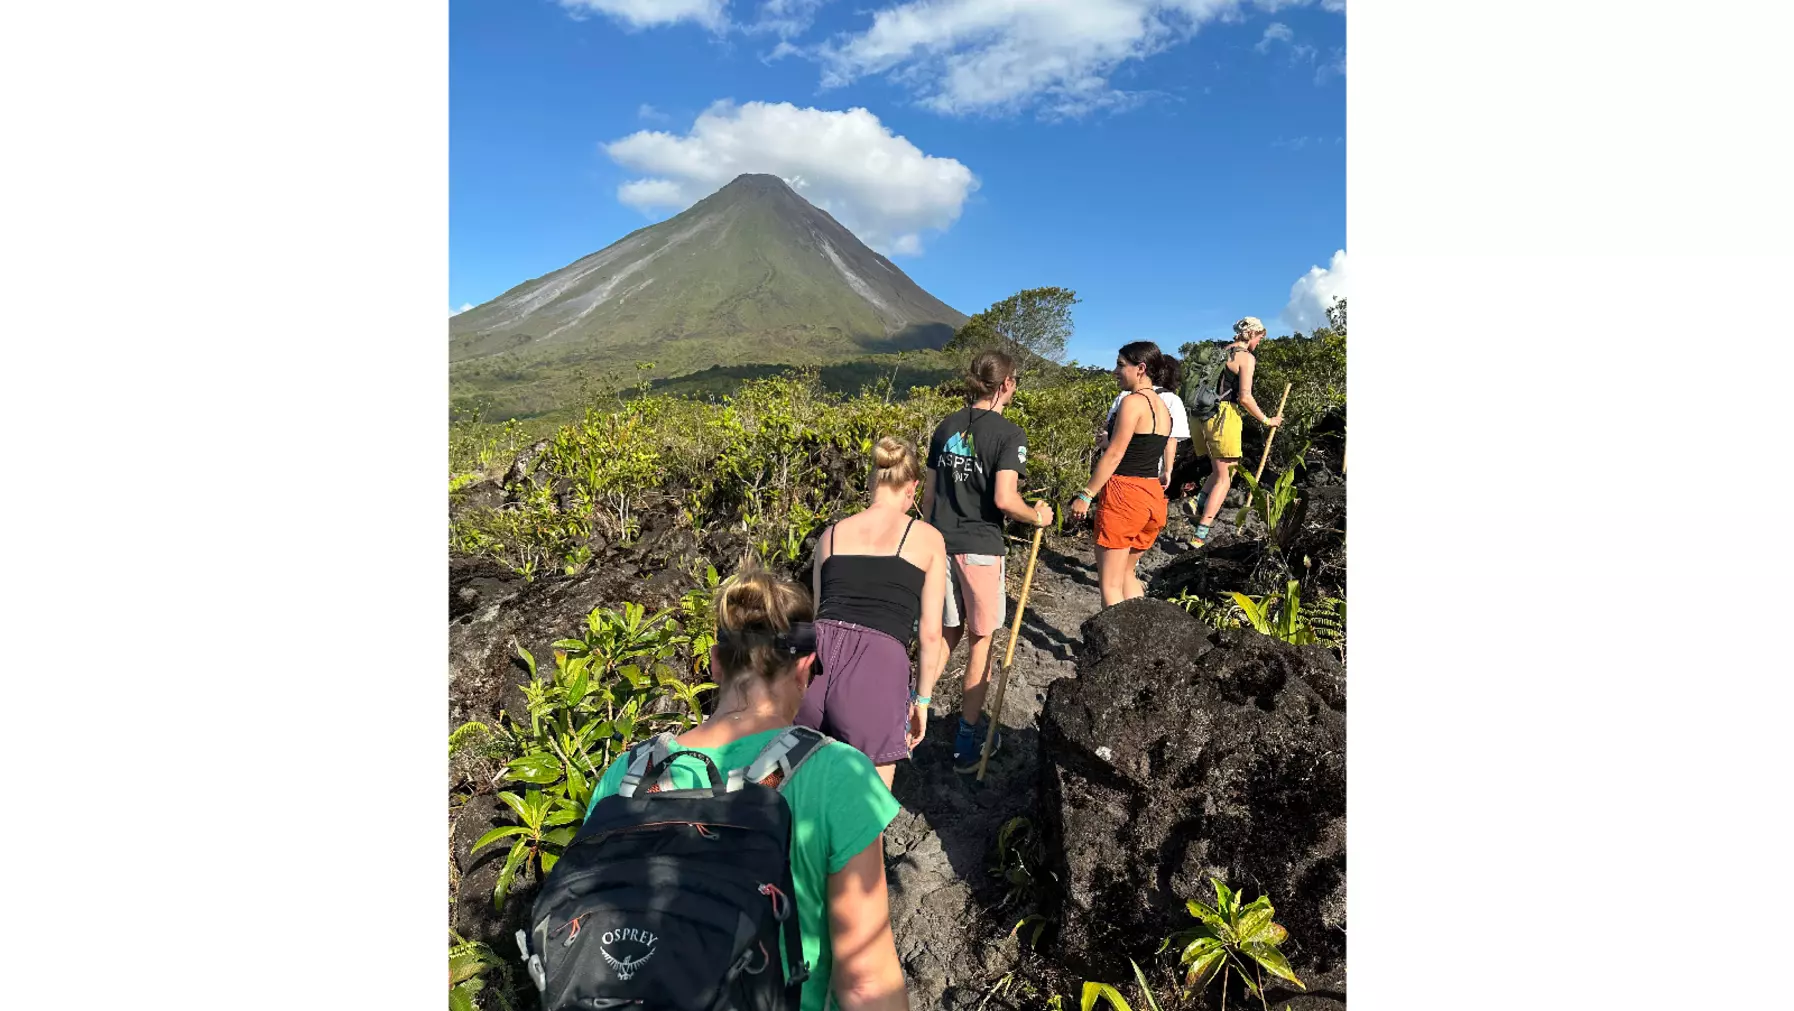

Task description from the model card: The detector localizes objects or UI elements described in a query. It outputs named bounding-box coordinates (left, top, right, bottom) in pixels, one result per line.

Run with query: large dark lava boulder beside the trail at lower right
left=1041, top=597, right=1346, bottom=1006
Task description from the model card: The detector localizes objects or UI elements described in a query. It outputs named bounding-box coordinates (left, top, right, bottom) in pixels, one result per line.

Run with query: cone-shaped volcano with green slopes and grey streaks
left=449, top=176, right=965, bottom=412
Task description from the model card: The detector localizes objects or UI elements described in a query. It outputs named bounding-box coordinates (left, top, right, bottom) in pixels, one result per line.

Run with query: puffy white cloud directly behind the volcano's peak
left=605, top=100, right=978, bottom=256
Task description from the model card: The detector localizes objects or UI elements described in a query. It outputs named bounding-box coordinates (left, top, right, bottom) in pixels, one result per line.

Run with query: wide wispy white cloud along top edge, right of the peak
left=818, top=0, right=1333, bottom=117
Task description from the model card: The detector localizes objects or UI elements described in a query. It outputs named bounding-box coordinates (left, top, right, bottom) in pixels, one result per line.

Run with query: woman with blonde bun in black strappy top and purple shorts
left=797, top=436, right=947, bottom=787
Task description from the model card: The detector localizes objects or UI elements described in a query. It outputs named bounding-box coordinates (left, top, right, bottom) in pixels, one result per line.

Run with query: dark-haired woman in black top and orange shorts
left=1071, top=341, right=1175, bottom=608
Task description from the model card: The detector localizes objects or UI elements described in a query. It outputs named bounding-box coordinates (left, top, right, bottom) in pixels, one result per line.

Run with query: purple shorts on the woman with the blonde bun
left=797, top=620, right=910, bottom=765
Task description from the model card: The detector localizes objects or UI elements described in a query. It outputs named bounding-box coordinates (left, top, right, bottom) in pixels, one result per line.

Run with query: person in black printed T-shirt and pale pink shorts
left=922, top=350, right=1053, bottom=773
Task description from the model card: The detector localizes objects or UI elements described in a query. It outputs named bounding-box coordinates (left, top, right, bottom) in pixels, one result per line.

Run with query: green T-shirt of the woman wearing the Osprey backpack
left=585, top=730, right=902, bottom=1011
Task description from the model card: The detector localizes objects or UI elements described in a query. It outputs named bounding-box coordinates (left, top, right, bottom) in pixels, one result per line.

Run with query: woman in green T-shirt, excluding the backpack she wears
left=587, top=563, right=910, bottom=1011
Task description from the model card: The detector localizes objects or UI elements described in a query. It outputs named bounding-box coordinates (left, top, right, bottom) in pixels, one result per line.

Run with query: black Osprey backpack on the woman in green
left=517, top=726, right=831, bottom=1011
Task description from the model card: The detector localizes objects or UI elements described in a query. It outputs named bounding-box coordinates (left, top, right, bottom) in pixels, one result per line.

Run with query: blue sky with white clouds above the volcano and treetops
left=449, top=0, right=1346, bottom=364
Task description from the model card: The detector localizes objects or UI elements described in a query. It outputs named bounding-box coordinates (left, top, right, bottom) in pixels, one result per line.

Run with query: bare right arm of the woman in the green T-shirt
left=829, top=835, right=910, bottom=1011
